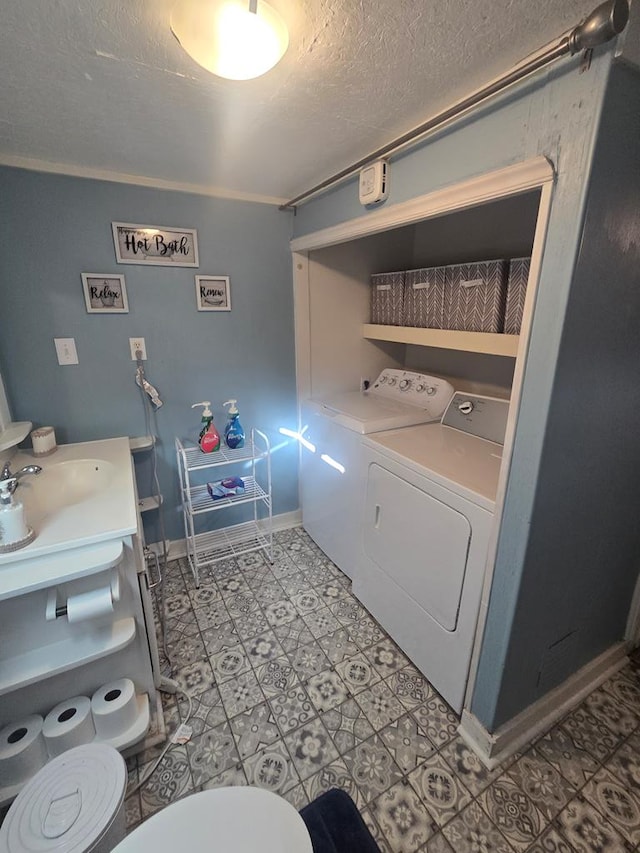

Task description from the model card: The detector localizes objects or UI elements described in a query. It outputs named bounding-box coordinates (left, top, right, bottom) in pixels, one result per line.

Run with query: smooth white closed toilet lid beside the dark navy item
left=113, top=787, right=313, bottom=853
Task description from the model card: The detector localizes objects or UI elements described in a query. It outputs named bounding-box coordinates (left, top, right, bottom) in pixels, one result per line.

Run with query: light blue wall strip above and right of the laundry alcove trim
left=294, top=45, right=613, bottom=731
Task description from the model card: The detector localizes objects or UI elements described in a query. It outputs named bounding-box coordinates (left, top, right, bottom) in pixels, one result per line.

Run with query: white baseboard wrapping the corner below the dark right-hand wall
left=458, top=643, right=629, bottom=770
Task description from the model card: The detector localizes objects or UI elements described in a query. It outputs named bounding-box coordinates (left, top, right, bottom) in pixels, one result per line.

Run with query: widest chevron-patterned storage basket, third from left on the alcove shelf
left=444, top=261, right=507, bottom=332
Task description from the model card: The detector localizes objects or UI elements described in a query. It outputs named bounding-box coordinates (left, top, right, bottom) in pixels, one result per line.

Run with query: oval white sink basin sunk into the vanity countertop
left=23, top=459, right=115, bottom=513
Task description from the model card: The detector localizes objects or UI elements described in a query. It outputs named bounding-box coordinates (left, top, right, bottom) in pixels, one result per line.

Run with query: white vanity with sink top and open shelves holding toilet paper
left=0, top=438, right=161, bottom=805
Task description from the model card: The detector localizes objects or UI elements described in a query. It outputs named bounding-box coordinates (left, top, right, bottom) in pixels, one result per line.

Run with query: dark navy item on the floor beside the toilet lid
left=300, top=788, right=380, bottom=853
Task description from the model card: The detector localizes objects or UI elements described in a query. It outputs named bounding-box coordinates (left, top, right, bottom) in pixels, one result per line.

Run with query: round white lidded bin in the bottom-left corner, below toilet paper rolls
left=0, top=744, right=127, bottom=853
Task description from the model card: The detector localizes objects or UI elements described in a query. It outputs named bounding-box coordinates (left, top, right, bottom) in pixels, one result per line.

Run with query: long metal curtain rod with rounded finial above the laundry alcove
left=279, top=0, right=629, bottom=210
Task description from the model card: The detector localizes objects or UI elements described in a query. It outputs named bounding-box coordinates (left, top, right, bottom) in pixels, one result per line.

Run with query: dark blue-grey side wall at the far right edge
left=479, top=60, right=640, bottom=725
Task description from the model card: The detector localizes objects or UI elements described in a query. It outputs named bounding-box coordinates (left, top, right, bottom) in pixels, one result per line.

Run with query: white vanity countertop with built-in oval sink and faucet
left=0, top=438, right=137, bottom=566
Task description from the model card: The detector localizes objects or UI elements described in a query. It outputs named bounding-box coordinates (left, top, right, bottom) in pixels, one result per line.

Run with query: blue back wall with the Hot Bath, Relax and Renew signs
left=0, top=168, right=298, bottom=541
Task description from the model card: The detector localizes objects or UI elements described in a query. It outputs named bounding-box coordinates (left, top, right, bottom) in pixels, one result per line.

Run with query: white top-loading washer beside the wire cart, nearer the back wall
left=300, top=368, right=453, bottom=578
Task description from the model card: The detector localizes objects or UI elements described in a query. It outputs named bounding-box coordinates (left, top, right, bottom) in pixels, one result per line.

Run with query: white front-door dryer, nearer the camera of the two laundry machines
left=353, top=392, right=509, bottom=713
